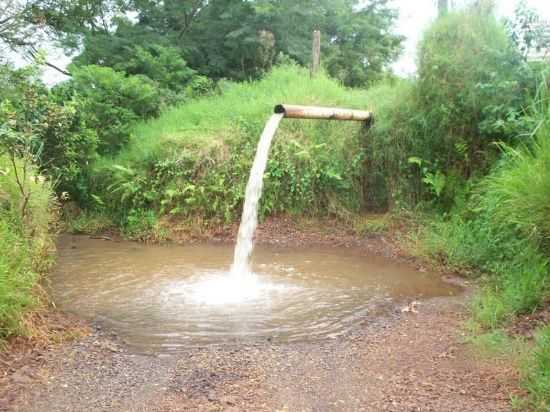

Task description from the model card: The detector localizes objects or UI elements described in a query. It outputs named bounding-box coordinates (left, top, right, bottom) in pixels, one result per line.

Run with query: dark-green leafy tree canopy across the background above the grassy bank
left=35, top=0, right=402, bottom=86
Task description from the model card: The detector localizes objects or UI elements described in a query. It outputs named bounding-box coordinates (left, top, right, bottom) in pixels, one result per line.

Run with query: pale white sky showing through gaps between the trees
left=9, top=0, right=550, bottom=85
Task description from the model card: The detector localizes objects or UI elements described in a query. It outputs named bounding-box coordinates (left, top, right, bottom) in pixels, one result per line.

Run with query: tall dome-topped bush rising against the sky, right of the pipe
left=417, top=6, right=528, bottom=171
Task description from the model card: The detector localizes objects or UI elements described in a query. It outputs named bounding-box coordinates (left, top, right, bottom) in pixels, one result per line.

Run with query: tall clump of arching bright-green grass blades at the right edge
left=477, top=77, right=550, bottom=326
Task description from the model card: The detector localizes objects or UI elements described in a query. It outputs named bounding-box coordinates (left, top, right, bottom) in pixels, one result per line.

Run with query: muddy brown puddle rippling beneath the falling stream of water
left=50, top=236, right=459, bottom=353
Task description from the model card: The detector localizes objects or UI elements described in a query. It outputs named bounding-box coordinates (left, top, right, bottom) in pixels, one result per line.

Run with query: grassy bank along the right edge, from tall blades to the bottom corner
left=411, top=83, right=550, bottom=412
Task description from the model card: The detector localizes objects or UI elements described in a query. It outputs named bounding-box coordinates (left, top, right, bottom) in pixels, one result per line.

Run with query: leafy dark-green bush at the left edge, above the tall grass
left=0, top=66, right=97, bottom=201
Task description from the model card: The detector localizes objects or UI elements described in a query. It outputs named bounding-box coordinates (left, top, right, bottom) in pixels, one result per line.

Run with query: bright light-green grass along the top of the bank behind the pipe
left=108, top=66, right=372, bottom=167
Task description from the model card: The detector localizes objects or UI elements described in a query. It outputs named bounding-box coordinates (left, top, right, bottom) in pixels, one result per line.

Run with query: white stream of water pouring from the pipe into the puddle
left=231, top=114, right=284, bottom=277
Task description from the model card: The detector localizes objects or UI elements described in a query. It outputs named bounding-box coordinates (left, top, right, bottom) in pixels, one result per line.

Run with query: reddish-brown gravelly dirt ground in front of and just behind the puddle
left=0, top=220, right=518, bottom=412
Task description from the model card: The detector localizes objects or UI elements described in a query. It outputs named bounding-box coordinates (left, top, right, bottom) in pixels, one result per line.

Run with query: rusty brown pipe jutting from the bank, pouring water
left=273, top=104, right=374, bottom=125
